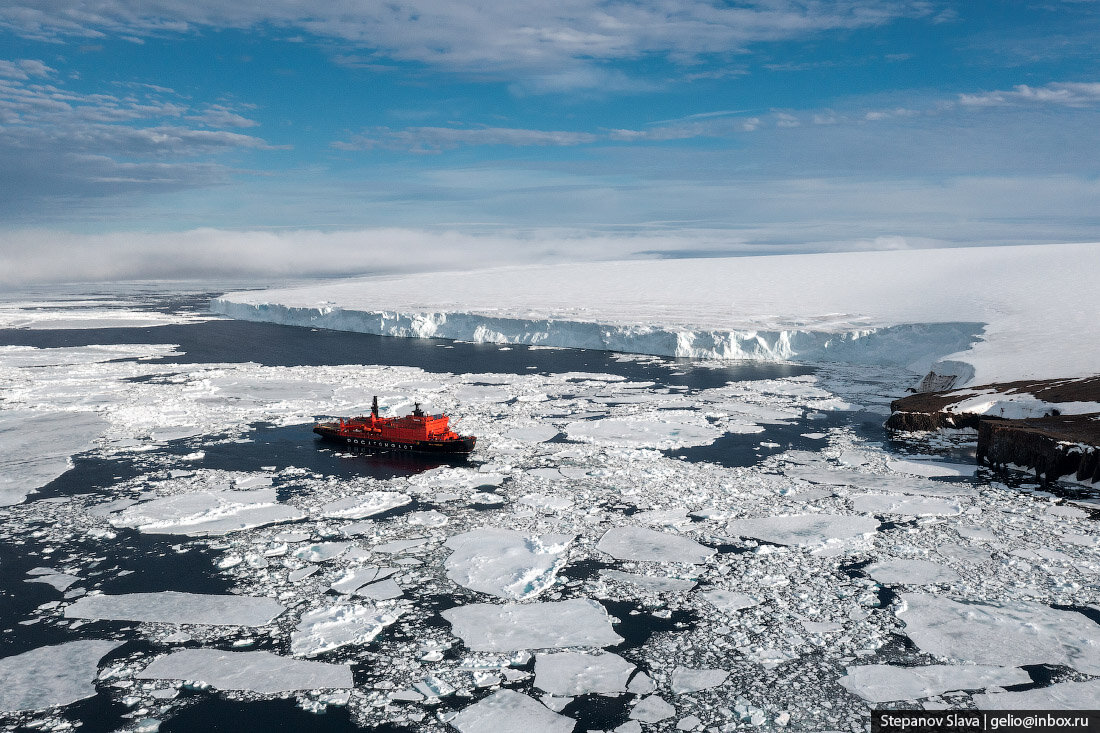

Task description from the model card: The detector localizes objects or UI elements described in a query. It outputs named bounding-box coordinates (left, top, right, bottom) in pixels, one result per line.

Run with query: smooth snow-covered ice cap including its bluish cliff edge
left=213, top=244, right=1100, bottom=384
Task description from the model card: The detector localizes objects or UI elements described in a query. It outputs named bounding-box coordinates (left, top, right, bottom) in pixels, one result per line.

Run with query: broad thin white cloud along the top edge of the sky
left=0, top=0, right=931, bottom=90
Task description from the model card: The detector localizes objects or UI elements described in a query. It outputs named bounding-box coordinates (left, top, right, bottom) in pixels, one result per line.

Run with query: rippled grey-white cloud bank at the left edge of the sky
left=0, top=59, right=272, bottom=208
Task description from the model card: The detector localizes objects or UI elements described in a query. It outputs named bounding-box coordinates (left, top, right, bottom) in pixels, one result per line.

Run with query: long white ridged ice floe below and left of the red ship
left=109, top=489, right=306, bottom=537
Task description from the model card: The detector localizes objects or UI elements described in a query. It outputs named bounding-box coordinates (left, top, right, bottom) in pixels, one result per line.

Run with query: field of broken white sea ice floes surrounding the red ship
left=0, top=269, right=1100, bottom=733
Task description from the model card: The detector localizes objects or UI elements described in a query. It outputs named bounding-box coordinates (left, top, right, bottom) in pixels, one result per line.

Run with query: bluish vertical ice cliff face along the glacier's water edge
left=210, top=297, right=983, bottom=376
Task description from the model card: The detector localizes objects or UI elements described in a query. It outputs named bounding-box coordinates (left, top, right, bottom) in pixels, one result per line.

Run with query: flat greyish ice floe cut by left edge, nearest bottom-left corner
left=0, top=641, right=122, bottom=712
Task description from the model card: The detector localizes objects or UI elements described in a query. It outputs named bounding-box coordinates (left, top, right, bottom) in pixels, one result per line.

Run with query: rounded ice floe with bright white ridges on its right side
left=444, top=527, right=573, bottom=601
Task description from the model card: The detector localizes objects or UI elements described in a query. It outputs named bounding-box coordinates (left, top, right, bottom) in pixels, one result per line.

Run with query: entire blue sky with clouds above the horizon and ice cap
left=0, top=0, right=1100, bottom=282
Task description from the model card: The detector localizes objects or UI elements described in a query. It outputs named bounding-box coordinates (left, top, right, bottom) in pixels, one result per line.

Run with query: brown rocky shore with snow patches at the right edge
left=887, top=376, right=1100, bottom=484
